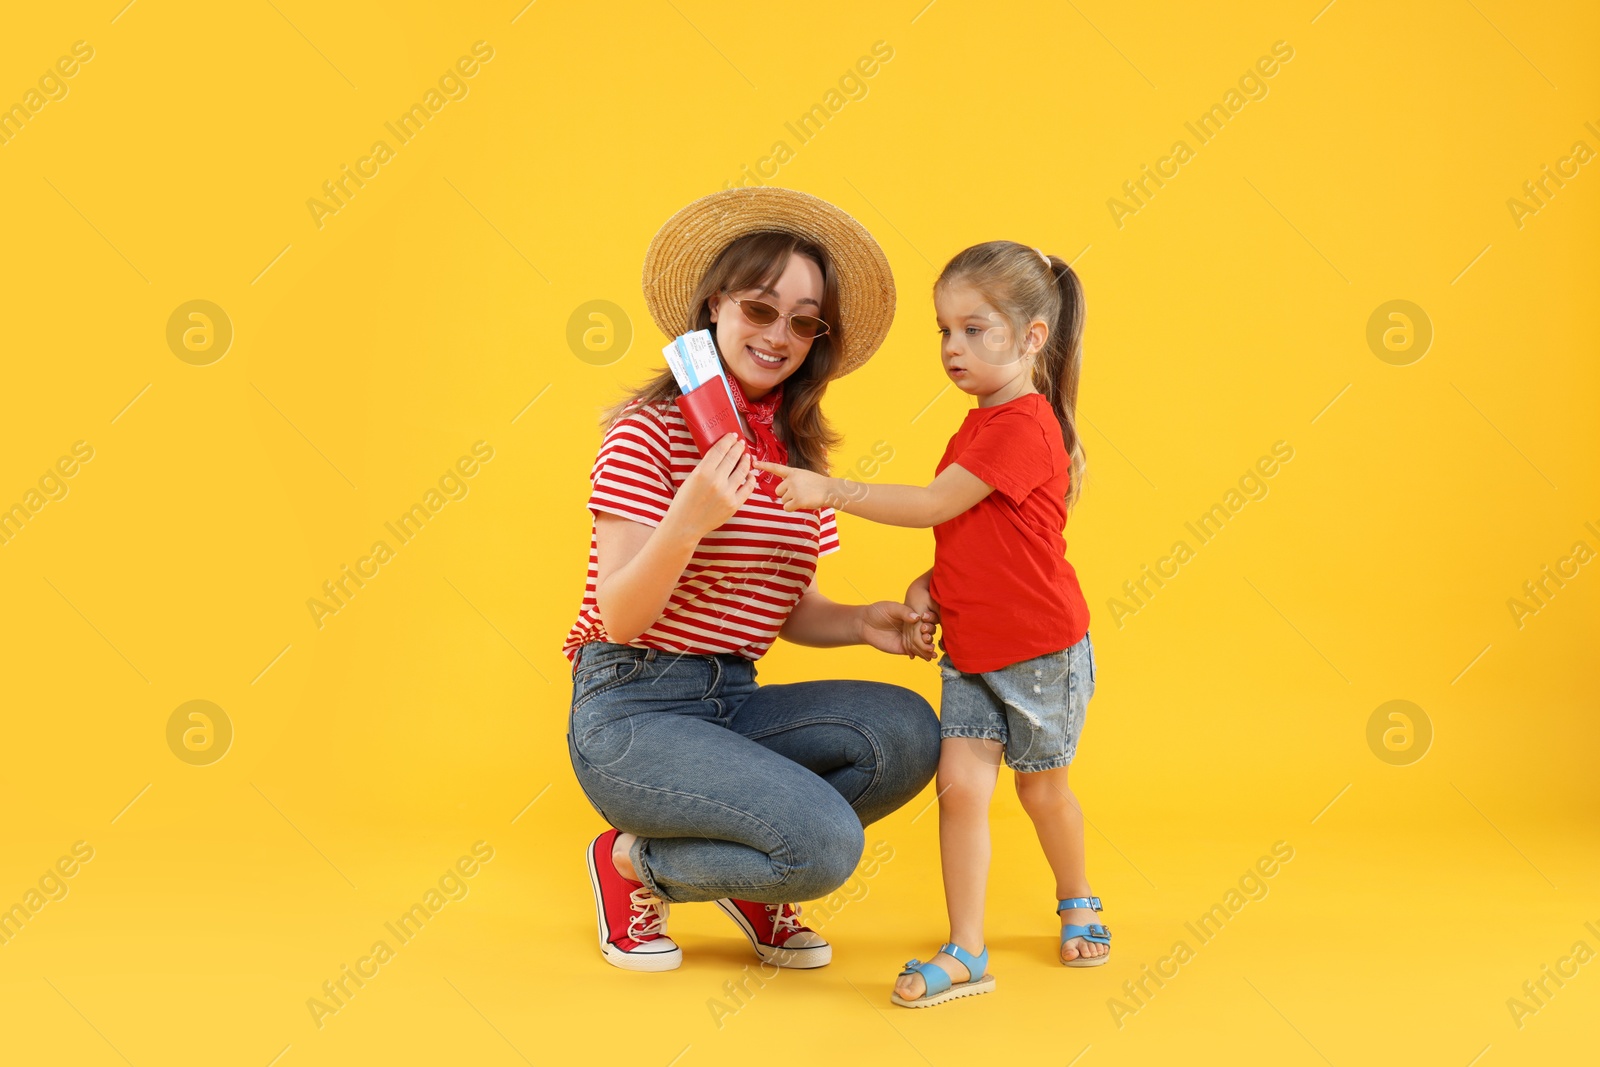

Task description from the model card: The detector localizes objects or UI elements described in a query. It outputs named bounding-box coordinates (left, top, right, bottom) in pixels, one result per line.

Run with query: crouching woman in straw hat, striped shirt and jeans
left=565, top=187, right=939, bottom=971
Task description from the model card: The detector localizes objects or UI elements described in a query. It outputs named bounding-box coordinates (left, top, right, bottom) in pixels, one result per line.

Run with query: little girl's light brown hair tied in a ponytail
left=933, top=242, right=1086, bottom=510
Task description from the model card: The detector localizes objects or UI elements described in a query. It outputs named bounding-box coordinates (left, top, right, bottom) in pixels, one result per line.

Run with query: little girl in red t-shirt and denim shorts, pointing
left=755, top=242, right=1110, bottom=1008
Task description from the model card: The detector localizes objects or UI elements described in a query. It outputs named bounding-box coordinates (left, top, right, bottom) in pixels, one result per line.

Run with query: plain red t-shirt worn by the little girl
left=930, top=392, right=1090, bottom=673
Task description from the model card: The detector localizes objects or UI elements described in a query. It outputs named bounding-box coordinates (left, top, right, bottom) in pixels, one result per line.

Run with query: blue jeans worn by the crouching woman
left=566, top=641, right=939, bottom=904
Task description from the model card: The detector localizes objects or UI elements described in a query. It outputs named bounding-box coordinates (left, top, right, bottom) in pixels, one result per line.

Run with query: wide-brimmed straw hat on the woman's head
left=643, top=186, right=894, bottom=378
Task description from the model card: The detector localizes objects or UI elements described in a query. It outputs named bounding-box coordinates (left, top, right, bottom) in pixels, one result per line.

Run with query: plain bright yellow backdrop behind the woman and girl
left=0, top=0, right=1600, bottom=1067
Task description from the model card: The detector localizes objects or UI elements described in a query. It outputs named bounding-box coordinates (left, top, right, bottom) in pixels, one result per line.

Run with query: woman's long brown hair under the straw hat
left=600, top=230, right=843, bottom=474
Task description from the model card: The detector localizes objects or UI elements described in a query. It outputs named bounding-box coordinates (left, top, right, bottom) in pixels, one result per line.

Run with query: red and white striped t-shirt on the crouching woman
left=562, top=402, right=838, bottom=661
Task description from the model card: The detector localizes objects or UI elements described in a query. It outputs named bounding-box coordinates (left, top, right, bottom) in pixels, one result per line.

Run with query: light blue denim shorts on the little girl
left=939, top=632, right=1094, bottom=773
